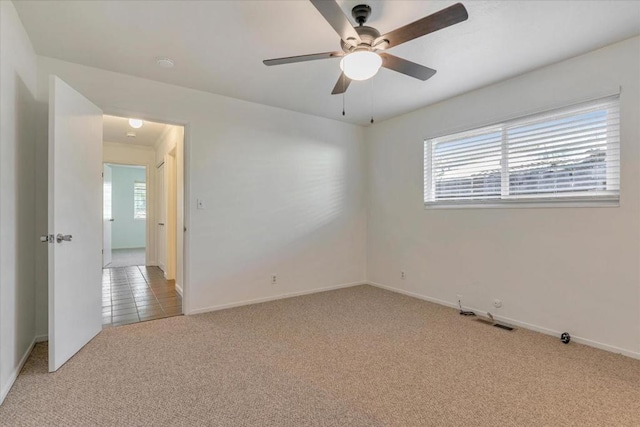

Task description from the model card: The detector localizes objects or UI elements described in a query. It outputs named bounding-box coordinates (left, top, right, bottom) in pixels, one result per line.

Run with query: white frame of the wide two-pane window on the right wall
left=423, top=97, right=622, bottom=209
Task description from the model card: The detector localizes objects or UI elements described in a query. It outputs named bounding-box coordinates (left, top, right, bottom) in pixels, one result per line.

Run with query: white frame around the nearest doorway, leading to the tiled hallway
left=102, top=106, right=192, bottom=315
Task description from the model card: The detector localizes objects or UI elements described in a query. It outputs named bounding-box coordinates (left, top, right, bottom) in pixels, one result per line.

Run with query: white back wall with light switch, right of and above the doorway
left=33, top=57, right=366, bottom=318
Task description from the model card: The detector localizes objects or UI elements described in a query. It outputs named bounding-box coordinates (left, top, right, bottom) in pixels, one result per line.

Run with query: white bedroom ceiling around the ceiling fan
left=15, top=0, right=640, bottom=124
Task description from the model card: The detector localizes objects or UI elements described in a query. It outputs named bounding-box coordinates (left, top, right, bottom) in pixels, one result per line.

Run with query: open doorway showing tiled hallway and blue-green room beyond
left=102, top=115, right=184, bottom=327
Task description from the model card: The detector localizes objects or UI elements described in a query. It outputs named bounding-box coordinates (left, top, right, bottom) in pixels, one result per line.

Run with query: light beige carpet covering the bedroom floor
left=0, top=286, right=640, bottom=426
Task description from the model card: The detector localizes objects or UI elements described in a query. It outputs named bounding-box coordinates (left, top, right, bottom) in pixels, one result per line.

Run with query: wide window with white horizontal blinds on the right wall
left=424, top=96, right=620, bottom=206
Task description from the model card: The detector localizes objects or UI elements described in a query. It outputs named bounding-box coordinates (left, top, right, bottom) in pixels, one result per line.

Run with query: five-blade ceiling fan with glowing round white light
left=263, top=0, right=469, bottom=95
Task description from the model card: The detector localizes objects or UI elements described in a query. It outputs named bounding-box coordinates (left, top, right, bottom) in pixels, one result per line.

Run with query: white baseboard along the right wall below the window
left=367, top=281, right=640, bottom=360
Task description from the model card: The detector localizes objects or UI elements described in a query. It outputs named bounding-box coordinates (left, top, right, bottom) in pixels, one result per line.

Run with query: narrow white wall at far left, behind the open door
left=0, top=1, right=37, bottom=403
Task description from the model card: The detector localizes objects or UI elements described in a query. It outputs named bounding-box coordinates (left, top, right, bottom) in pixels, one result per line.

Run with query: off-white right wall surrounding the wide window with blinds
left=366, top=37, right=640, bottom=357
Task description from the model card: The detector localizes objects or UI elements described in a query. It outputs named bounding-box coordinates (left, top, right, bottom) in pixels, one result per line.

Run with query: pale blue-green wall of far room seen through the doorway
left=111, top=164, right=147, bottom=249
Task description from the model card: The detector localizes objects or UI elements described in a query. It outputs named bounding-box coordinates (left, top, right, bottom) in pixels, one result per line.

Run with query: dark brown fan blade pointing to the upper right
left=373, top=3, right=469, bottom=48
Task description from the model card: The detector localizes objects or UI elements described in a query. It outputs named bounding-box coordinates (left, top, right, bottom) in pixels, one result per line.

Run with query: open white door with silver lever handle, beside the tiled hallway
left=48, top=76, right=102, bottom=372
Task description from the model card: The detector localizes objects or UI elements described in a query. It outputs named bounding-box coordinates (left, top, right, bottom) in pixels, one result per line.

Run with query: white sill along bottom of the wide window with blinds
left=424, top=197, right=620, bottom=210
